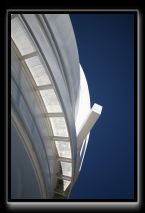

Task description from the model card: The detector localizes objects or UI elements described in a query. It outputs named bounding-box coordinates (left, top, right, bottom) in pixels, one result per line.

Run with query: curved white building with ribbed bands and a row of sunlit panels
left=11, top=14, right=101, bottom=199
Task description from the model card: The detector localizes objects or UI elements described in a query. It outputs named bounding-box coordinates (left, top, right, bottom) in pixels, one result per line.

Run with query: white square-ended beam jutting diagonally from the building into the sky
left=77, top=104, right=102, bottom=147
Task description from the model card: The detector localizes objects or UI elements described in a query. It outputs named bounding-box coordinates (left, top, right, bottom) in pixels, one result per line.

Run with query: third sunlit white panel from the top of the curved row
left=40, top=89, right=62, bottom=113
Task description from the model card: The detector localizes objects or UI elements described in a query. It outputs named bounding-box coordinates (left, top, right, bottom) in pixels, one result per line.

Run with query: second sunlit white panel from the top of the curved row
left=25, top=56, right=51, bottom=86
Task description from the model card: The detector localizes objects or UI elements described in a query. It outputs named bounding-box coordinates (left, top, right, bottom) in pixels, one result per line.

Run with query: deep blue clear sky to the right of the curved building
left=70, top=14, right=134, bottom=199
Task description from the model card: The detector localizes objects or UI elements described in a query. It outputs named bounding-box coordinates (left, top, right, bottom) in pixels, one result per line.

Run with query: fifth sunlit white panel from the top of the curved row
left=55, top=141, right=71, bottom=158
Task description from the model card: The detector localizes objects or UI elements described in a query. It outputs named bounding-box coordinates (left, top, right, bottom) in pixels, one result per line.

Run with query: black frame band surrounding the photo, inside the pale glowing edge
left=6, top=9, right=139, bottom=204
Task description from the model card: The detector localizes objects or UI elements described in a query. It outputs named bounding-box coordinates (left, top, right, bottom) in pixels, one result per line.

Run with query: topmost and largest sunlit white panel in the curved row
left=11, top=17, right=35, bottom=56
